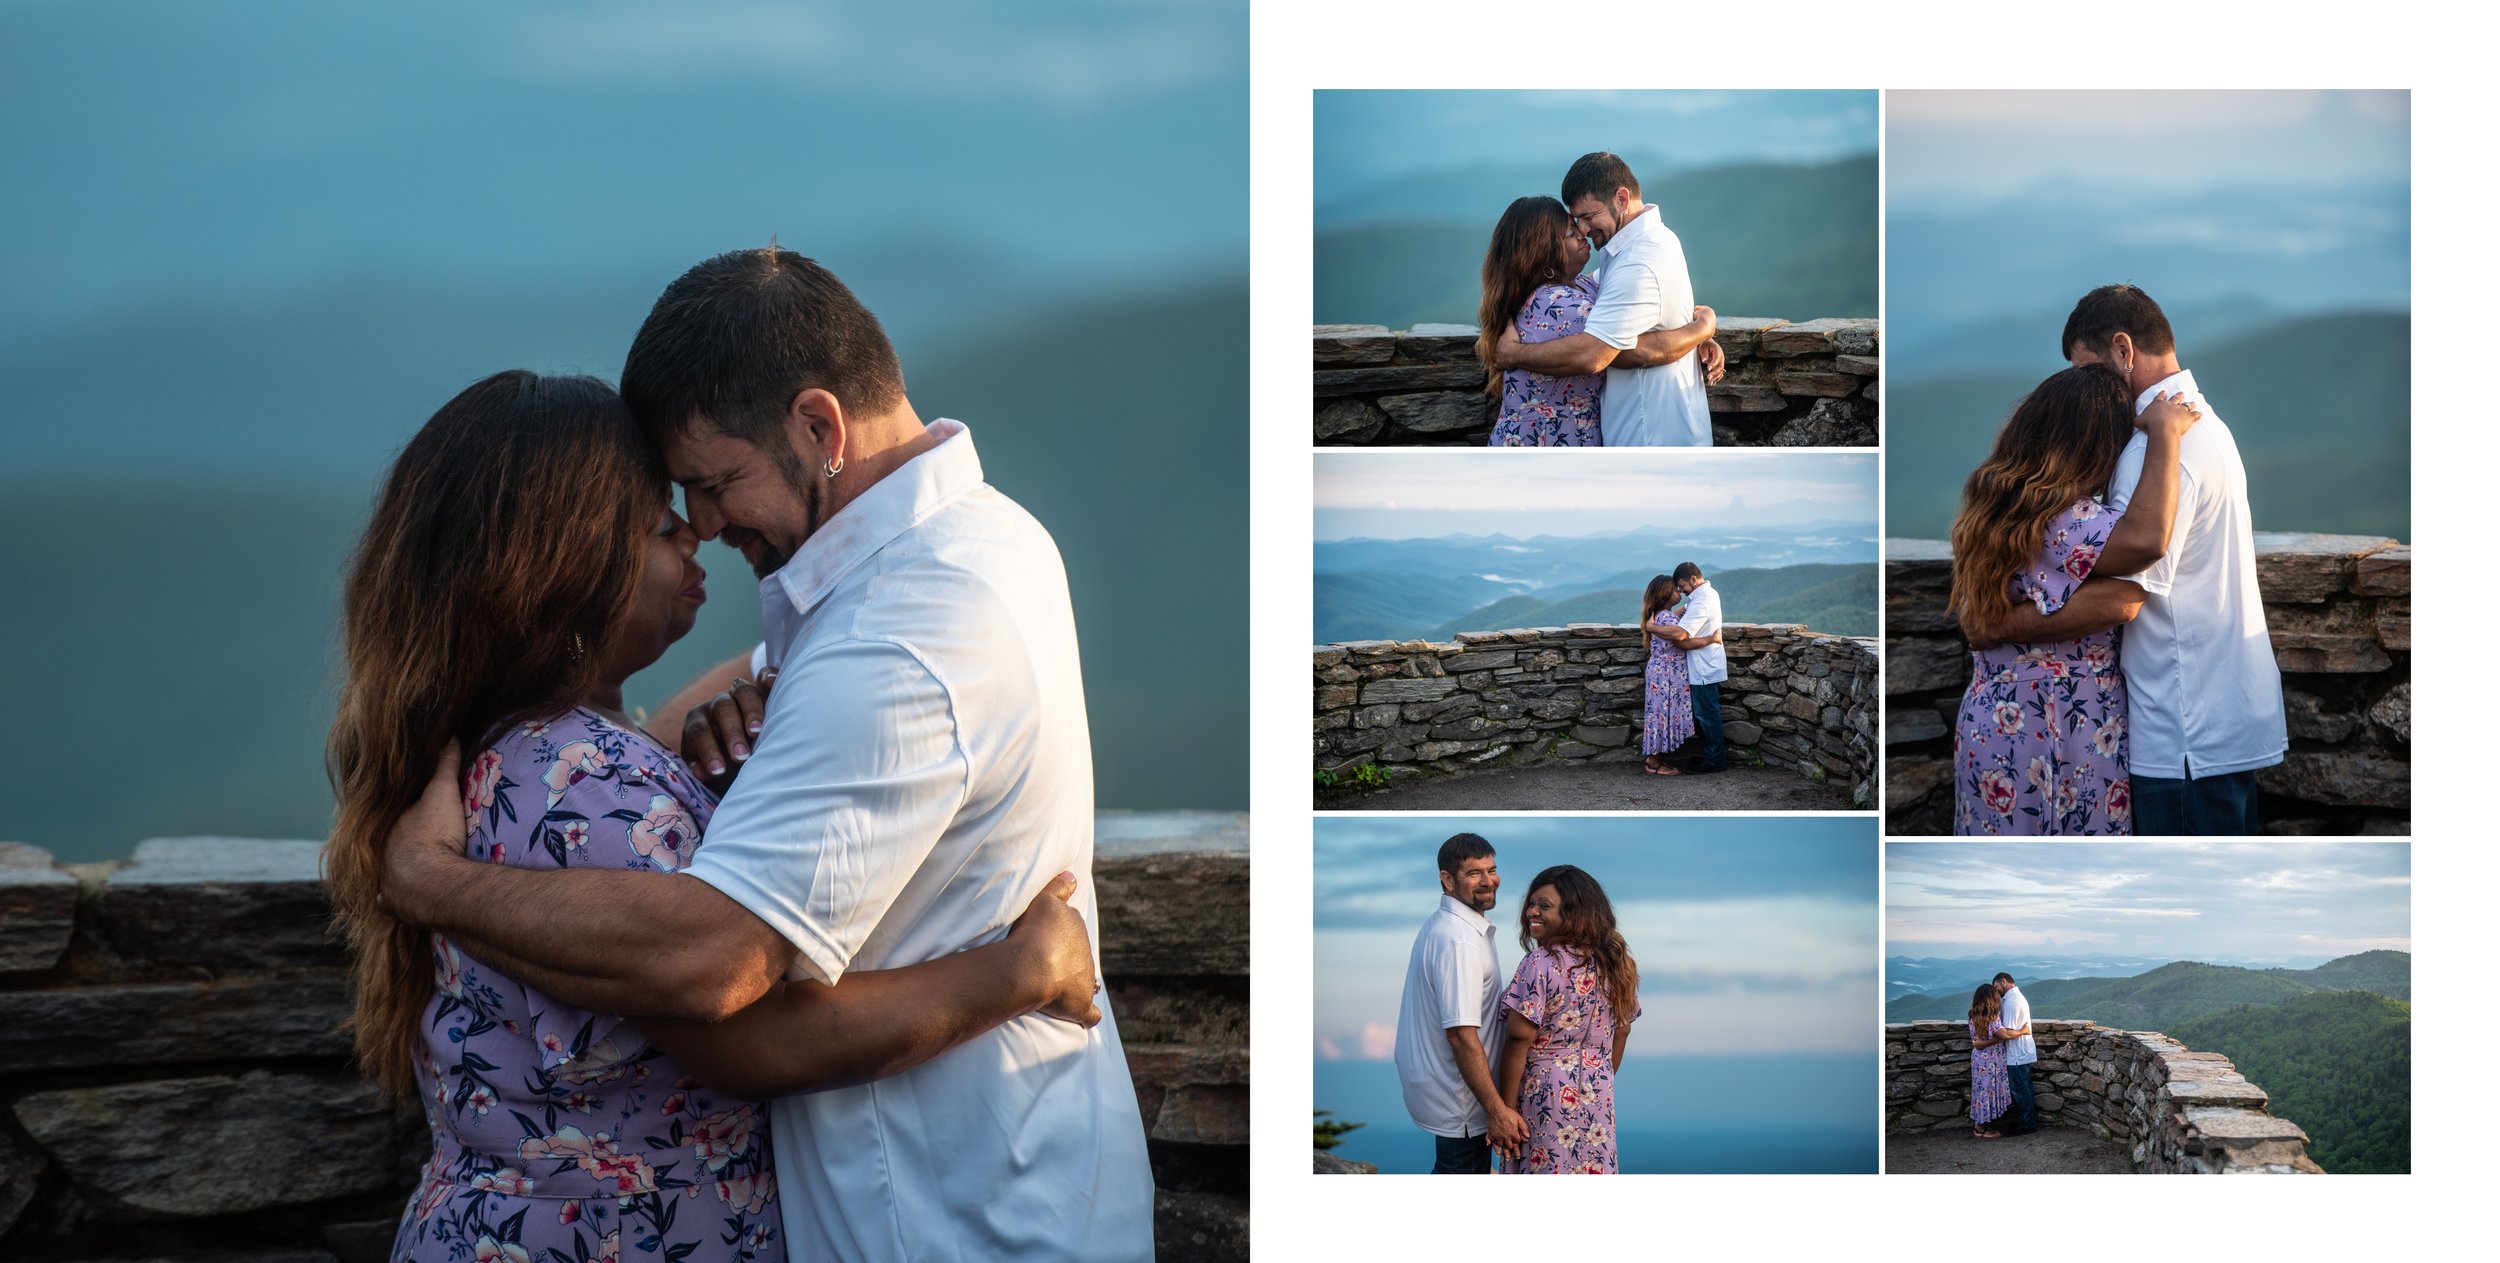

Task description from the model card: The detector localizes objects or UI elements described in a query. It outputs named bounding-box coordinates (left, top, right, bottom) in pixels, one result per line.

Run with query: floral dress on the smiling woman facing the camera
left=1503, top=945, right=1640, bottom=1175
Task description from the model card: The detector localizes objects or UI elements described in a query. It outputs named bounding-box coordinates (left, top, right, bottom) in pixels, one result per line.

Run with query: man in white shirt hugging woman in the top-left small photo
left=1493, top=153, right=1728, bottom=448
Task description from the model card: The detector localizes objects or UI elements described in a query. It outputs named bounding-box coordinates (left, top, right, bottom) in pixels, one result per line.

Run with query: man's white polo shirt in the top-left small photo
left=1583, top=205, right=1710, bottom=448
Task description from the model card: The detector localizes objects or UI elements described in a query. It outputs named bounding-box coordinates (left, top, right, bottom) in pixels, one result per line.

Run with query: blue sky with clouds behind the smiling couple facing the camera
left=1313, top=815, right=1878, bottom=1060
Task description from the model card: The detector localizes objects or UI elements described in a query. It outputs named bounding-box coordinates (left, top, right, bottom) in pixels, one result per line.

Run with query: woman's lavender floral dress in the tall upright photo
left=1953, top=500, right=2135, bottom=835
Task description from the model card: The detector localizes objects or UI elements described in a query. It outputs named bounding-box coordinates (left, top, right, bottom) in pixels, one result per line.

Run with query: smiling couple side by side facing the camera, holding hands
left=1398, top=833, right=1640, bottom=1175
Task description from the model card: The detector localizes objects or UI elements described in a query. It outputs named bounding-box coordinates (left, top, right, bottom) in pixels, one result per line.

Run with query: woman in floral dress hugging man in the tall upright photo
left=1950, top=365, right=2195, bottom=835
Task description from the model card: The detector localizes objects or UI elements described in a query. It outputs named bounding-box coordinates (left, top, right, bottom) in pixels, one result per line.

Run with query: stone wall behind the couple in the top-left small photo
left=1310, top=318, right=1883, bottom=448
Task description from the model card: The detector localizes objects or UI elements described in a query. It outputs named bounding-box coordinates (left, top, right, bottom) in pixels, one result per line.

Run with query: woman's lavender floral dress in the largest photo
left=390, top=710, right=783, bottom=1263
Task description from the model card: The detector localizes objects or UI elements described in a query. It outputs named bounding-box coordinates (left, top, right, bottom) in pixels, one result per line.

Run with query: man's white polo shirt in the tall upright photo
left=2110, top=370, right=2293, bottom=778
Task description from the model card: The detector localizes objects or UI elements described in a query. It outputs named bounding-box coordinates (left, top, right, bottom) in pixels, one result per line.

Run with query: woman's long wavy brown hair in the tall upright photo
left=1945, top=365, right=2135, bottom=635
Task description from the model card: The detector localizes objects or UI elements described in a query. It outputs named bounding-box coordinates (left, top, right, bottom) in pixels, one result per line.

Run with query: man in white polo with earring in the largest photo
left=385, top=248, right=1155, bottom=1260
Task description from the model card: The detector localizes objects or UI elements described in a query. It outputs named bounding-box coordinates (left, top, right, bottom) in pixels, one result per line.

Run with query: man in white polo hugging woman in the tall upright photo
left=2005, top=285, right=2293, bottom=838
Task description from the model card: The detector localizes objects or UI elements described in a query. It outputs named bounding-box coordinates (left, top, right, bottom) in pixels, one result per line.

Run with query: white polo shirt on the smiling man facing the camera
left=1398, top=895, right=1503, bottom=1140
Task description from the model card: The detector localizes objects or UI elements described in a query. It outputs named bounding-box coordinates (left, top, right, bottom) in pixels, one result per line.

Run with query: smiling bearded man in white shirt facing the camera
left=1398, top=833, right=1528, bottom=1175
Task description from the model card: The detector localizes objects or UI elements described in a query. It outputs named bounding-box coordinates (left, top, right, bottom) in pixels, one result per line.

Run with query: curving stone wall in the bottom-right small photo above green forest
left=1883, top=1020, right=2318, bottom=1175
